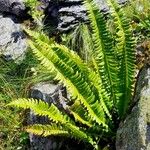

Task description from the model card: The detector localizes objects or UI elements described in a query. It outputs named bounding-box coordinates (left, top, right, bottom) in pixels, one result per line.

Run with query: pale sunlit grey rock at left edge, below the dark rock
left=0, top=15, right=27, bottom=62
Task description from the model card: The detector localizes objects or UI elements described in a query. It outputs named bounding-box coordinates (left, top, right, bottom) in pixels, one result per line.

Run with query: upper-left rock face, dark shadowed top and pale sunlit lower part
left=0, top=0, right=29, bottom=62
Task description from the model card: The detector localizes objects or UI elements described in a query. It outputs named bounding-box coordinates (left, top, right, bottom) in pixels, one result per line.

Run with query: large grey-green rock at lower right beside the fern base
left=116, top=64, right=150, bottom=150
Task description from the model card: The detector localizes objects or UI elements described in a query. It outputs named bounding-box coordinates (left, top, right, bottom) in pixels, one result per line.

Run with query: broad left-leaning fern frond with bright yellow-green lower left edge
left=25, top=30, right=107, bottom=127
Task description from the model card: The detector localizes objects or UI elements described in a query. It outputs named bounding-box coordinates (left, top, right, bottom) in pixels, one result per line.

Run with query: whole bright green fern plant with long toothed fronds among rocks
left=9, top=0, right=135, bottom=149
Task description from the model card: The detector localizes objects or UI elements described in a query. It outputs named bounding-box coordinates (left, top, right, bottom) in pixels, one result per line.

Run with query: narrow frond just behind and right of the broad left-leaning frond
left=52, top=44, right=111, bottom=118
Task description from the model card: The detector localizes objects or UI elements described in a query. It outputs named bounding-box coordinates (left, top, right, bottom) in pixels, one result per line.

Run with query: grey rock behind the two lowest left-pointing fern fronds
left=29, top=83, right=66, bottom=150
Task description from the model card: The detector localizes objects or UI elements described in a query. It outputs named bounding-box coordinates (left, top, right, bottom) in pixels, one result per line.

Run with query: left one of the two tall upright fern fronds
left=84, top=0, right=119, bottom=106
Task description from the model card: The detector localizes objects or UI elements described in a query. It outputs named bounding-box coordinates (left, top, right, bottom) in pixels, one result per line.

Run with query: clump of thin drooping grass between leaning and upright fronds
left=62, top=23, right=93, bottom=62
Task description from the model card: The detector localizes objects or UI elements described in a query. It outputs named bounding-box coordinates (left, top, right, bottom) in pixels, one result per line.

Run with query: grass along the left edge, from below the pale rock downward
left=0, top=51, right=54, bottom=150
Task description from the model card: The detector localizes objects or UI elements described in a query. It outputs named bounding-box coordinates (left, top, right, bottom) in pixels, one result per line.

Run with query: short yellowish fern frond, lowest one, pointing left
left=26, top=124, right=69, bottom=137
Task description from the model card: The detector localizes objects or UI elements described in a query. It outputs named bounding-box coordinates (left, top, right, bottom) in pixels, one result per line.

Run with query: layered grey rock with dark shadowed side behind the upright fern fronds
left=41, top=0, right=127, bottom=33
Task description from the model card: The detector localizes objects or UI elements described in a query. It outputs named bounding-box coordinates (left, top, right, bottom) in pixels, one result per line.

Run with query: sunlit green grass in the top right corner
left=124, top=0, right=150, bottom=42
